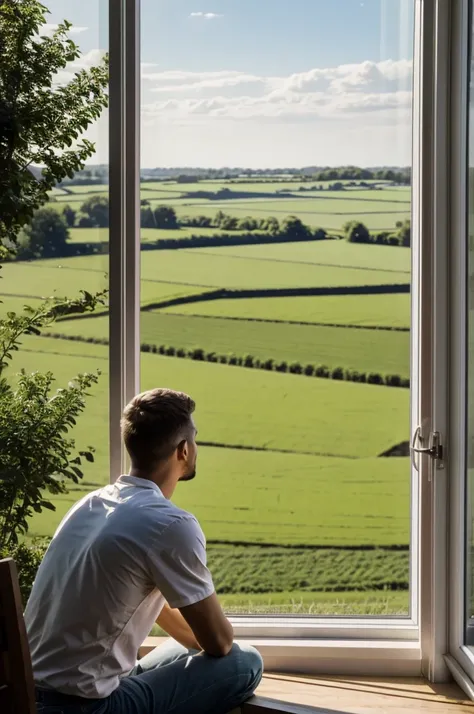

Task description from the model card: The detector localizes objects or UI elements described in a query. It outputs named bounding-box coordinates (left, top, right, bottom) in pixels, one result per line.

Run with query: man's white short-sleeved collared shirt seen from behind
left=25, top=476, right=214, bottom=699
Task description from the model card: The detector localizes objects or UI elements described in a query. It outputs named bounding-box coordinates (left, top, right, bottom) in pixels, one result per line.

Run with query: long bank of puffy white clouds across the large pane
left=143, top=60, right=412, bottom=121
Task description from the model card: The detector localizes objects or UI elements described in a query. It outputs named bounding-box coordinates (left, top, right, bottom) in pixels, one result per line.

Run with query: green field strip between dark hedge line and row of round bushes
left=53, top=312, right=410, bottom=377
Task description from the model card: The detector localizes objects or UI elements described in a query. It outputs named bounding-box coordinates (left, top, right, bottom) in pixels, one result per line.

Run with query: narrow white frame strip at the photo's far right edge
left=446, top=0, right=474, bottom=699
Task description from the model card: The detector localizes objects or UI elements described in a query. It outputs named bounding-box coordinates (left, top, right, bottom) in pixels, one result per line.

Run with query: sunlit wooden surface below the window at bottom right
left=241, top=674, right=474, bottom=714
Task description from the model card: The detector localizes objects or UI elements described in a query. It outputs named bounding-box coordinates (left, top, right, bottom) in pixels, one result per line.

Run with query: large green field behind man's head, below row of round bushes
left=15, top=337, right=409, bottom=546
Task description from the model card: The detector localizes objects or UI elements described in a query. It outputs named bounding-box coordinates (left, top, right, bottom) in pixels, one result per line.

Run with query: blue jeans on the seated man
left=37, top=639, right=263, bottom=714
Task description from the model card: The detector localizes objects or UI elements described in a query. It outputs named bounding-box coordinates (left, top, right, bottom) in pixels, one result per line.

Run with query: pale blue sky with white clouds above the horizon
left=45, top=0, right=414, bottom=168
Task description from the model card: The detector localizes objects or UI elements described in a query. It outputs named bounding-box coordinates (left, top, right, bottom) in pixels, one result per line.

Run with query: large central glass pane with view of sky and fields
left=141, top=0, right=414, bottom=615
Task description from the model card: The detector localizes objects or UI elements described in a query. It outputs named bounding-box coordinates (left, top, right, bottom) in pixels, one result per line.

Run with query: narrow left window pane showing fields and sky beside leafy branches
left=0, top=0, right=109, bottom=538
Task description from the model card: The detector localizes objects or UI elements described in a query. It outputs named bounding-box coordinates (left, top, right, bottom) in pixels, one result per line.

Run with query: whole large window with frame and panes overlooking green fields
left=15, top=0, right=474, bottom=689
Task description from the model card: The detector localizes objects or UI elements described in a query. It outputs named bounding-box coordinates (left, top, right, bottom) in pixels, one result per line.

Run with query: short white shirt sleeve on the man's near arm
left=147, top=516, right=214, bottom=608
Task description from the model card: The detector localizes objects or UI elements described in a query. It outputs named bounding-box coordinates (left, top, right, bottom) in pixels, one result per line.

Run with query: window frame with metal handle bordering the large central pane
left=109, top=0, right=453, bottom=681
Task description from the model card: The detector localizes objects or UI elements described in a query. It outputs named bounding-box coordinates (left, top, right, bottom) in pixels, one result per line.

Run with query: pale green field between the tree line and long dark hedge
left=0, top=243, right=410, bottom=300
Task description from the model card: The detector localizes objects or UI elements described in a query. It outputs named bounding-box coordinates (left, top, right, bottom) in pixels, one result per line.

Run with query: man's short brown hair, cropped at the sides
left=121, top=389, right=196, bottom=470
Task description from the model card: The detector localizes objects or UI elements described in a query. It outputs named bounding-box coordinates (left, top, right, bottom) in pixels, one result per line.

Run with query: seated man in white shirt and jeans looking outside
left=25, top=389, right=262, bottom=714
